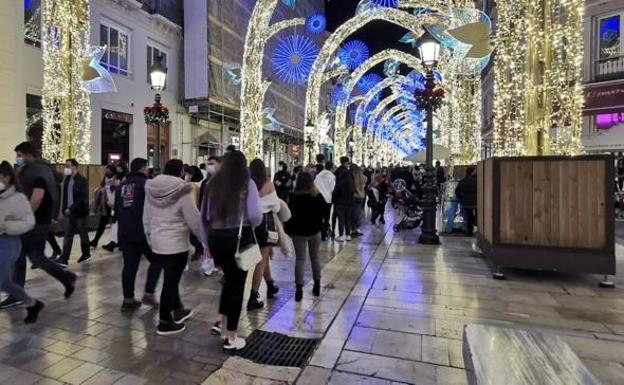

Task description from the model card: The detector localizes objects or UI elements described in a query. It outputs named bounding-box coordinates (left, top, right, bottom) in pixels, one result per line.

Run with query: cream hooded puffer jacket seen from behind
left=143, top=175, right=200, bottom=255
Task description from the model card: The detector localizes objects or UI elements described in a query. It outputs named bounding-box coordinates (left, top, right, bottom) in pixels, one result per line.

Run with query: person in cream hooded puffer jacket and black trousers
left=143, top=159, right=199, bottom=335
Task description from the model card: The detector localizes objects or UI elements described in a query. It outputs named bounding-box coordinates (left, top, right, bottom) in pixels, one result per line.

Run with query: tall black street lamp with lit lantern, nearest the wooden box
left=418, top=30, right=440, bottom=245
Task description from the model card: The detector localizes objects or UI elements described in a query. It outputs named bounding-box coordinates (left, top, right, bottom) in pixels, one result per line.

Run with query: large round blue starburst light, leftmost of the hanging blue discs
left=272, top=35, right=319, bottom=84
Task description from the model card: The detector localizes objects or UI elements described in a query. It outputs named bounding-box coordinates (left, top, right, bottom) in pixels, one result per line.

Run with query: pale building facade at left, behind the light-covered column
left=6, top=0, right=185, bottom=164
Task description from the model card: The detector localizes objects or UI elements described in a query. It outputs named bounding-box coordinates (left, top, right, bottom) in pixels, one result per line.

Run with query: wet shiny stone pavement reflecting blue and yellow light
left=0, top=218, right=624, bottom=385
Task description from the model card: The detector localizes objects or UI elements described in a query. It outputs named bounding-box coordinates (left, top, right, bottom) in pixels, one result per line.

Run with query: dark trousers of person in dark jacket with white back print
left=121, top=242, right=162, bottom=299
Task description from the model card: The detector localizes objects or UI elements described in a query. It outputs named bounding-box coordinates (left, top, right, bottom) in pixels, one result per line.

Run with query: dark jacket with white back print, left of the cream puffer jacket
left=115, top=173, right=147, bottom=244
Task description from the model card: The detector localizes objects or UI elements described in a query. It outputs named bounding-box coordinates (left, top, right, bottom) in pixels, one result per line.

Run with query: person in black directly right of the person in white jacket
left=332, top=156, right=355, bottom=242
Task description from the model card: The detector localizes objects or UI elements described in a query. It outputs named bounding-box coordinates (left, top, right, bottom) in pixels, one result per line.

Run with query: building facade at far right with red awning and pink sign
left=583, top=0, right=624, bottom=152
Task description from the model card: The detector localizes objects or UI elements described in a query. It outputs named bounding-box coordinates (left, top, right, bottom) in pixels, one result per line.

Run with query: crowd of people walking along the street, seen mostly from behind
left=0, top=142, right=476, bottom=350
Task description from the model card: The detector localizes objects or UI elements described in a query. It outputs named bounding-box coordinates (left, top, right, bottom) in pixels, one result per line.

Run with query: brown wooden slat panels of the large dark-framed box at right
left=498, top=159, right=613, bottom=249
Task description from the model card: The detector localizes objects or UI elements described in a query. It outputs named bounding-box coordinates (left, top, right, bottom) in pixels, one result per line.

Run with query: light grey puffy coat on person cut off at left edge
left=0, top=186, right=35, bottom=236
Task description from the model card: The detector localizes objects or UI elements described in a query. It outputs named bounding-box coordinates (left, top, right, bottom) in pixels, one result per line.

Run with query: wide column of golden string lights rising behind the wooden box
left=494, top=0, right=585, bottom=156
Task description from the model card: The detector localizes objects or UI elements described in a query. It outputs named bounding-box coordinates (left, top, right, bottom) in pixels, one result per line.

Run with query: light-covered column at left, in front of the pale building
left=41, top=0, right=91, bottom=164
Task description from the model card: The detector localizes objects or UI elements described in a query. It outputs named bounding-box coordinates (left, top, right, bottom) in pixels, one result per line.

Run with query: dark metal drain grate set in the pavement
left=238, top=330, right=320, bottom=368
